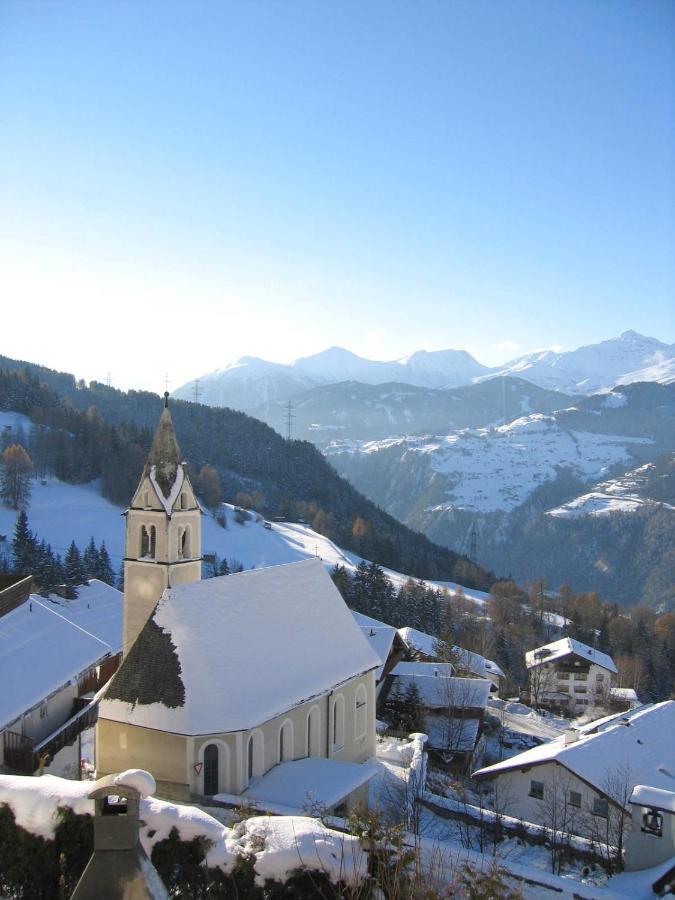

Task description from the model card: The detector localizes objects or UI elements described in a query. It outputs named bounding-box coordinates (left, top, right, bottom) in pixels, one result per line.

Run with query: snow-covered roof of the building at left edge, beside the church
left=0, top=581, right=122, bottom=727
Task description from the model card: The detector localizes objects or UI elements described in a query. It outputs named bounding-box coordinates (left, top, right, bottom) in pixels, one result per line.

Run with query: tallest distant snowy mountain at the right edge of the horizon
left=486, top=331, right=675, bottom=394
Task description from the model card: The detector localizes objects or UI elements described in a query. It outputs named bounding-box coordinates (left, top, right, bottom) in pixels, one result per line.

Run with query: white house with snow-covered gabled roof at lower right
left=473, top=700, right=675, bottom=838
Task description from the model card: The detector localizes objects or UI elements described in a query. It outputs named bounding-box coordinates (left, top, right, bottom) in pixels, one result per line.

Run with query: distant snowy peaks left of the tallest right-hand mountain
left=174, top=347, right=492, bottom=412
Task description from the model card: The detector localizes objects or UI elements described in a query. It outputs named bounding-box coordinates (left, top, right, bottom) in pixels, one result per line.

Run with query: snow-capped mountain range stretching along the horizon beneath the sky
left=175, top=331, right=675, bottom=412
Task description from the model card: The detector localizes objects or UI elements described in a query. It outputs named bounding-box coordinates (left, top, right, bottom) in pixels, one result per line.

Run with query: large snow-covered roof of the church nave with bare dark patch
left=100, top=559, right=380, bottom=735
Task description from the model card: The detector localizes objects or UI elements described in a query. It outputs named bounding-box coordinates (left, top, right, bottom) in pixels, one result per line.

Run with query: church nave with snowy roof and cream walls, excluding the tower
left=102, top=559, right=381, bottom=798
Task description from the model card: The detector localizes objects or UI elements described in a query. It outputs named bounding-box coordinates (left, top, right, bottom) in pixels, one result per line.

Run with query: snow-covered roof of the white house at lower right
left=474, top=700, right=675, bottom=790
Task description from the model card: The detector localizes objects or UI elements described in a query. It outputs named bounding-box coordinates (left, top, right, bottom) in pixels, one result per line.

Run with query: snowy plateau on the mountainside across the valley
left=326, top=413, right=650, bottom=513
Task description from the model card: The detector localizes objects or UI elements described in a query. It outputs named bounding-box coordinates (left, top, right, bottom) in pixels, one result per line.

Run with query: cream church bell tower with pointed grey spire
left=124, top=392, right=201, bottom=655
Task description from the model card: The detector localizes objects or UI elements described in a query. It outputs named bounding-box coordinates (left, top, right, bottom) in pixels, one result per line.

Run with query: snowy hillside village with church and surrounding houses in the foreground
left=0, top=395, right=675, bottom=898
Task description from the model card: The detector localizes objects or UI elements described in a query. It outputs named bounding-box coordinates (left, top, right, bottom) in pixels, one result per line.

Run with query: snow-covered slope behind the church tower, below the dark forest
left=0, top=478, right=487, bottom=603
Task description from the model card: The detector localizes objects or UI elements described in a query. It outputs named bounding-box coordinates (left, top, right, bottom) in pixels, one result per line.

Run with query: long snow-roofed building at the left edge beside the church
left=0, top=579, right=122, bottom=772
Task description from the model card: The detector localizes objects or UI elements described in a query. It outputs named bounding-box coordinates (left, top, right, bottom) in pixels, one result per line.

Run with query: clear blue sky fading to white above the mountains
left=0, top=0, right=675, bottom=390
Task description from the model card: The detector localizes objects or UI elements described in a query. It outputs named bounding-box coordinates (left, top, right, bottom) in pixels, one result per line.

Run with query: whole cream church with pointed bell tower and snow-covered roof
left=96, top=394, right=380, bottom=808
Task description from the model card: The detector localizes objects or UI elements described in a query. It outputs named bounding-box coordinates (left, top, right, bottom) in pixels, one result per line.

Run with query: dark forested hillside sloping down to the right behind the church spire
left=0, top=357, right=494, bottom=589
